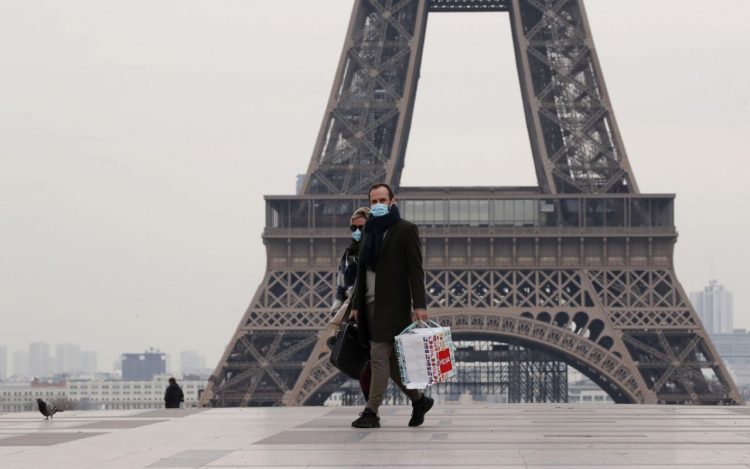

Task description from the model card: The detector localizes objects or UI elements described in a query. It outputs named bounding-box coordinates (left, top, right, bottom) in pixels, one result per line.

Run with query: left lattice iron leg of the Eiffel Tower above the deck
left=303, top=0, right=427, bottom=194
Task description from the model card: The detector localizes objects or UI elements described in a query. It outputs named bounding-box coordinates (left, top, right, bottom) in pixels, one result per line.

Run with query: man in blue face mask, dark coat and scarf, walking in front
left=352, top=184, right=434, bottom=428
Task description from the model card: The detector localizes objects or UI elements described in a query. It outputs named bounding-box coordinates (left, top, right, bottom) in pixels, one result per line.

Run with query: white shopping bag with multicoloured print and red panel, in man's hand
left=396, top=321, right=456, bottom=389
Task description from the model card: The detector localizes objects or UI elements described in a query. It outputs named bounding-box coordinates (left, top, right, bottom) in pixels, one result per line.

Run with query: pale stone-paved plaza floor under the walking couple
left=0, top=404, right=750, bottom=469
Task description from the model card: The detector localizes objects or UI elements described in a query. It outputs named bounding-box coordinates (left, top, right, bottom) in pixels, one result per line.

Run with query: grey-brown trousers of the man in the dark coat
left=365, top=303, right=422, bottom=414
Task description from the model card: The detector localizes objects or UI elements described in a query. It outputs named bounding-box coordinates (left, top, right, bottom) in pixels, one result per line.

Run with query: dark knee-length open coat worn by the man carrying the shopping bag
left=352, top=219, right=426, bottom=343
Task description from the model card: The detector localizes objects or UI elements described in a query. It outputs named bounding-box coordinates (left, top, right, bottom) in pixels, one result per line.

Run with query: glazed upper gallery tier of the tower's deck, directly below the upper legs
left=264, top=189, right=676, bottom=233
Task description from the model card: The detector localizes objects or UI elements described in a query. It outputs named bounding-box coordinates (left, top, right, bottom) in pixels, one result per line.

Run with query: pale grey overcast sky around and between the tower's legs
left=0, top=0, right=750, bottom=369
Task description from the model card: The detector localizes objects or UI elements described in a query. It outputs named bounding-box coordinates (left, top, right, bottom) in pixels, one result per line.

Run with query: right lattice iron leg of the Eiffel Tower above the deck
left=510, top=0, right=638, bottom=194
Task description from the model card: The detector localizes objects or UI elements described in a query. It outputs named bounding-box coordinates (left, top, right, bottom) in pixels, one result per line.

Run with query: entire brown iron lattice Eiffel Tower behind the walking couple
left=202, top=0, right=742, bottom=406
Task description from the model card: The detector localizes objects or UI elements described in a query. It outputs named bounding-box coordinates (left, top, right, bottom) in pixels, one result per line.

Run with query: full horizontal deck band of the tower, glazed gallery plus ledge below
left=263, top=192, right=677, bottom=270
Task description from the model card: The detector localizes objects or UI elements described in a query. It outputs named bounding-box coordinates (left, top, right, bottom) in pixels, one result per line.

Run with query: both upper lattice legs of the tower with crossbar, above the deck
left=303, top=0, right=638, bottom=194
